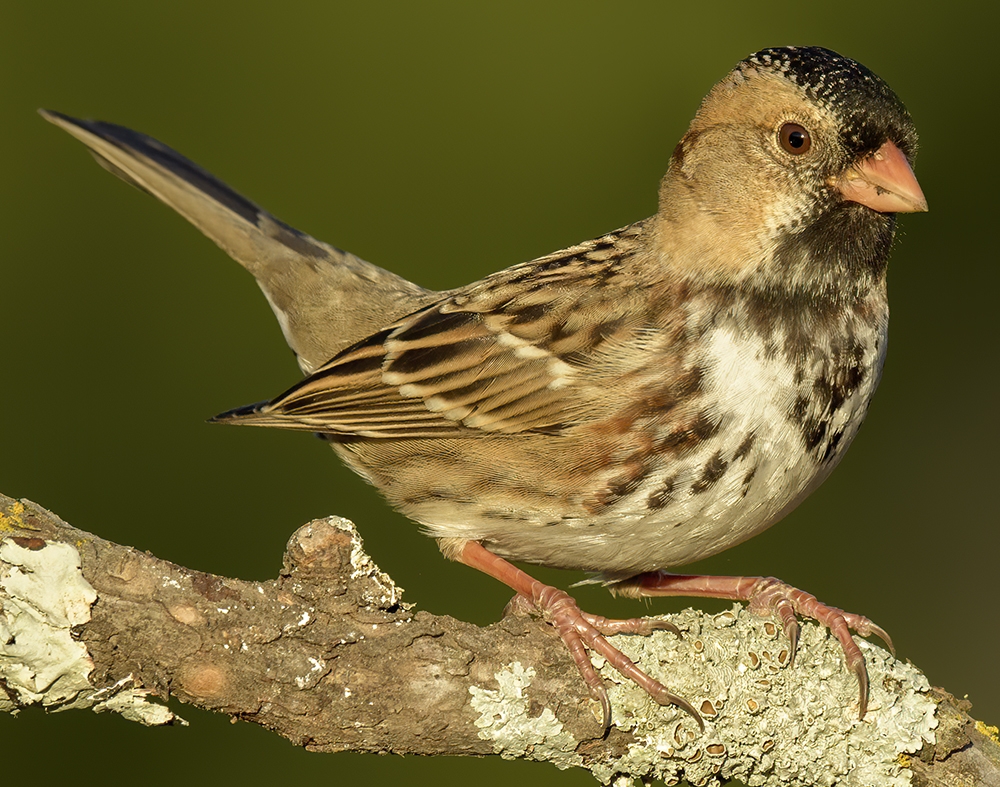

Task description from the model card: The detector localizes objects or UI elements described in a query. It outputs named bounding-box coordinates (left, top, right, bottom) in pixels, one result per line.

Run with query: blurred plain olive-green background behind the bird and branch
left=0, top=0, right=1000, bottom=787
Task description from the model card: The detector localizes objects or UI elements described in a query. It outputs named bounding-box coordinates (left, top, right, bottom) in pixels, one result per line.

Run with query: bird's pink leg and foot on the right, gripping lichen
left=614, top=571, right=896, bottom=719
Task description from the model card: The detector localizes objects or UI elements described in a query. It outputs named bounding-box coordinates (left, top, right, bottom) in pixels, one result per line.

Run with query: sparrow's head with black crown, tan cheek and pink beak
left=660, top=47, right=927, bottom=302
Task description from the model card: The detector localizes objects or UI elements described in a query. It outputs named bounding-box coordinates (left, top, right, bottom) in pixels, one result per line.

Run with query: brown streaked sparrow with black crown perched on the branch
left=41, top=47, right=927, bottom=729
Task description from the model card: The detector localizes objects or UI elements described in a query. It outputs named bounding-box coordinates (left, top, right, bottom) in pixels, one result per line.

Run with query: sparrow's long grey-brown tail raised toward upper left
left=39, top=109, right=435, bottom=372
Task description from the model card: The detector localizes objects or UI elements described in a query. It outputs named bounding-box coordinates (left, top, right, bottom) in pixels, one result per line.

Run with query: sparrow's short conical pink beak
left=829, top=142, right=927, bottom=213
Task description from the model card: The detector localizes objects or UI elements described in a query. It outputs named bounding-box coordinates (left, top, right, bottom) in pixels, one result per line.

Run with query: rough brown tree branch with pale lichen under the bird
left=0, top=496, right=1000, bottom=786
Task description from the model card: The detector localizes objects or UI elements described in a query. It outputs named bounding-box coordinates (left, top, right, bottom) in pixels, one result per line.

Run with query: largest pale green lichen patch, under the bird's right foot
left=591, top=606, right=937, bottom=787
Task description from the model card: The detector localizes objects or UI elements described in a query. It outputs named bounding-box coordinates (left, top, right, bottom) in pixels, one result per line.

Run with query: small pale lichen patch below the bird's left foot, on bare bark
left=469, top=661, right=583, bottom=769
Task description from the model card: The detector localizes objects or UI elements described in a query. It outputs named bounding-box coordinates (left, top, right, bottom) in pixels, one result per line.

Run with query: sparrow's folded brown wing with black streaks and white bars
left=216, top=222, right=656, bottom=438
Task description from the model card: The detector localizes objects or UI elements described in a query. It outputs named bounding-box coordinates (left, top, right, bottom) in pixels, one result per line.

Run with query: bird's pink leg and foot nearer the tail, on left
left=458, top=541, right=705, bottom=730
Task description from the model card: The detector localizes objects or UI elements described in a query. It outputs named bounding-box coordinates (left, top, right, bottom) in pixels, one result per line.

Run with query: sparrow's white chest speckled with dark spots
left=610, top=298, right=888, bottom=573
